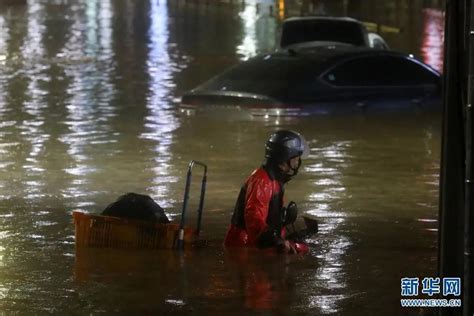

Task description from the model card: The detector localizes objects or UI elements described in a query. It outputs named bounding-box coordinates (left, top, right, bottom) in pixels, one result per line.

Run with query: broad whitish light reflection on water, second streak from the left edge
left=58, top=1, right=118, bottom=207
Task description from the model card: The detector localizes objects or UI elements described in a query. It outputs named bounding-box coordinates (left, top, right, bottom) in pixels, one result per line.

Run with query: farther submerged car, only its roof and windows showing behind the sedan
left=280, top=16, right=388, bottom=49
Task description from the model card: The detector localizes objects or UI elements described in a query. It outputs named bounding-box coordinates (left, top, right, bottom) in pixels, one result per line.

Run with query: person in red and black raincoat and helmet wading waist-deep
left=224, top=130, right=309, bottom=253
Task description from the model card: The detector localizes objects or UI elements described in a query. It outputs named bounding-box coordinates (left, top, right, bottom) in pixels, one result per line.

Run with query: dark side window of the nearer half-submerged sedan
left=324, top=56, right=438, bottom=86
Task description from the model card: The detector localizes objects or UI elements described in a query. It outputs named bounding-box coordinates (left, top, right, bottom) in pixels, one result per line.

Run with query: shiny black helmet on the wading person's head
left=265, top=130, right=309, bottom=163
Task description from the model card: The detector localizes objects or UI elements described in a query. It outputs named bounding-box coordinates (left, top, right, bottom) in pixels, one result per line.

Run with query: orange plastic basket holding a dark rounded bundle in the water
left=72, top=211, right=196, bottom=249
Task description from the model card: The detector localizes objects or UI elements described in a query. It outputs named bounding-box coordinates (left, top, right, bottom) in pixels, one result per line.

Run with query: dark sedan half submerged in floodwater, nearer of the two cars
left=181, top=44, right=441, bottom=115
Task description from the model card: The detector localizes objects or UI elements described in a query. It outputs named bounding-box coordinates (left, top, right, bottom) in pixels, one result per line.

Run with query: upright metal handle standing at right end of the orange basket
left=177, top=160, right=207, bottom=249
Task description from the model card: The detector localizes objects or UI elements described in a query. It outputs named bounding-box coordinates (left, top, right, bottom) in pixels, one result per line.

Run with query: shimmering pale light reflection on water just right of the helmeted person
left=304, top=141, right=351, bottom=314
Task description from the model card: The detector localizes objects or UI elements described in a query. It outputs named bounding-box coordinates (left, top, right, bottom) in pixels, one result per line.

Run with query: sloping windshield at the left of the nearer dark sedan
left=199, top=55, right=319, bottom=99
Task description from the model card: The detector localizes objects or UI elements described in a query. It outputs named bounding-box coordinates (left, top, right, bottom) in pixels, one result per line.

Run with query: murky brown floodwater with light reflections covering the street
left=0, top=0, right=443, bottom=315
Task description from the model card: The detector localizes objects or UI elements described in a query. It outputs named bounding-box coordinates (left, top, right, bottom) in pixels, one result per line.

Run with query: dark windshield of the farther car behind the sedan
left=280, top=20, right=366, bottom=47
